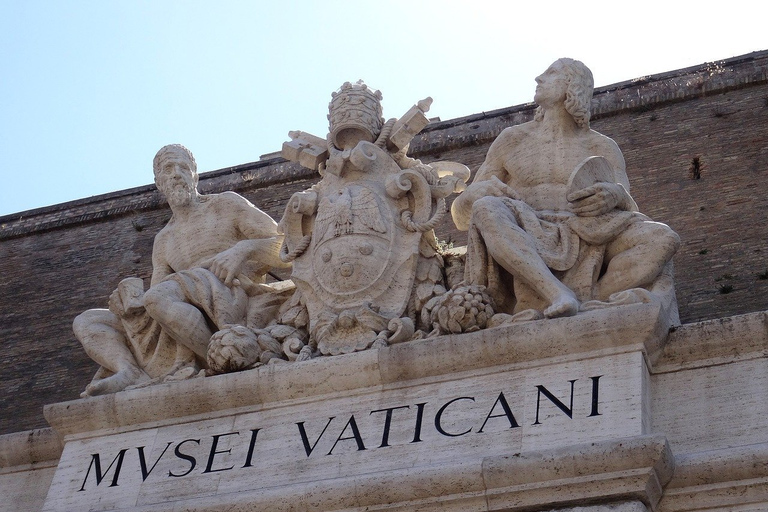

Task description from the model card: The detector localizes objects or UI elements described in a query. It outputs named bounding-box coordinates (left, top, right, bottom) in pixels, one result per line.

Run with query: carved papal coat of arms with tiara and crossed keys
left=280, top=82, right=469, bottom=355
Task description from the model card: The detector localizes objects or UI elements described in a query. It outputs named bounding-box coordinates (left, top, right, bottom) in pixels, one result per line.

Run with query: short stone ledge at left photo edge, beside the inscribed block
left=0, top=428, right=63, bottom=473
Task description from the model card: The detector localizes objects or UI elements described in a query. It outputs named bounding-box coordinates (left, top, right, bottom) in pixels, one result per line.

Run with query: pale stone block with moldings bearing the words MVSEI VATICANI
left=44, top=304, right=674, bottom=512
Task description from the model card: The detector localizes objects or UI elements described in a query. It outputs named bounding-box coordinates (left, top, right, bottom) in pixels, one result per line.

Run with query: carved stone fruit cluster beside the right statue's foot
left=421, top=285, right=494, bottom=335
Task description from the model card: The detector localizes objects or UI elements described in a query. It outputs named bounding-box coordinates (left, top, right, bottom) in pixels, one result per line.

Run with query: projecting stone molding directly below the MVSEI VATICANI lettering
left=42, top=436, right=674, bottom=512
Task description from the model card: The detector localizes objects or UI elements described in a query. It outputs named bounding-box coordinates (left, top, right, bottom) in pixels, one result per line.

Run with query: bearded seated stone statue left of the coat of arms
left=73, top=144, right=289, bottom=396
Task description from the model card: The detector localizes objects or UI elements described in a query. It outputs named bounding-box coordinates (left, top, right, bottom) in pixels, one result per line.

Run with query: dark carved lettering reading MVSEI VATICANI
left=77, top=375, right=602, bottom=492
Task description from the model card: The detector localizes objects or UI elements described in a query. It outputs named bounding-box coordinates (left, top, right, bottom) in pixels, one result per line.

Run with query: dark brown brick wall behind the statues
left=0, top=52, right=768, bottom=434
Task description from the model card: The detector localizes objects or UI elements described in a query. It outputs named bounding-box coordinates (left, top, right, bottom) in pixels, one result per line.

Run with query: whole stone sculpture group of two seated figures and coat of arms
left=74, top=59, right=680, bottom=396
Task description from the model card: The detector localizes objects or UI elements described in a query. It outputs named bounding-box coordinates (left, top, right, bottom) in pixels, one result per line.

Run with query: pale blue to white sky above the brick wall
left=0, top=0, right=768, bottom=215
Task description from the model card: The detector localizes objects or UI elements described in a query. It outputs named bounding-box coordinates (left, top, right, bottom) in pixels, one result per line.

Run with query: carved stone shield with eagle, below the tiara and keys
left=292, top=143, right=421, bottom=351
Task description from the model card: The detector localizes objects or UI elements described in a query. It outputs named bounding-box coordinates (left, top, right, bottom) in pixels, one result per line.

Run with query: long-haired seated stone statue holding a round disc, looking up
left=452, top=59, right=680, bottom=318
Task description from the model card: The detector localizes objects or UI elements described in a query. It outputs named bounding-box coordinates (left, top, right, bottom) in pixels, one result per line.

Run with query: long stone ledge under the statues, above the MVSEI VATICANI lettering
left=44, top=304, right=668, bottom=437
